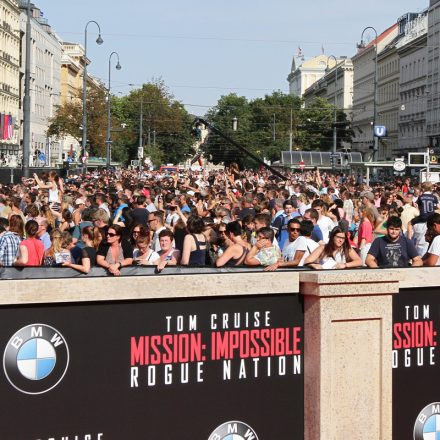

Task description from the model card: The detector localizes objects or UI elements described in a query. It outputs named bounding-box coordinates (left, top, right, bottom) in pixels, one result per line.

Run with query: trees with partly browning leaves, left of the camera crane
left=48, top=80, right=195, bottom=165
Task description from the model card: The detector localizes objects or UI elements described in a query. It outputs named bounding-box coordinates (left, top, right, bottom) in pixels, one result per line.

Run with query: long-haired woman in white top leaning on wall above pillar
left=304, top=226, right=362, bottom=269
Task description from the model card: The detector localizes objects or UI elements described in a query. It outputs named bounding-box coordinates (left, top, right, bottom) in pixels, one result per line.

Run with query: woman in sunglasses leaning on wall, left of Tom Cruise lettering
left=96, top=225, right=133, bottom=276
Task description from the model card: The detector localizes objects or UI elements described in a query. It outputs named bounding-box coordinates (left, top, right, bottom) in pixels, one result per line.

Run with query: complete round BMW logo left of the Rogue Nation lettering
left=3, top=324, right=69, bottom=394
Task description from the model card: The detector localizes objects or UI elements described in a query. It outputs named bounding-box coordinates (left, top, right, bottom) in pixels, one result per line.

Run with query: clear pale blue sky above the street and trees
left=33, top=0, right=429, bottom=116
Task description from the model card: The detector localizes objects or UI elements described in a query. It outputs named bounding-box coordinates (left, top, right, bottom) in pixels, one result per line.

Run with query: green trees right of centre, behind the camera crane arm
left=202, top=91, right=351, bottom=166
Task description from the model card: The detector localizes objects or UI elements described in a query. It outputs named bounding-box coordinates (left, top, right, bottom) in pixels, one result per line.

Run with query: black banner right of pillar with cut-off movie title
left=392, top=288, right=440, bottom=440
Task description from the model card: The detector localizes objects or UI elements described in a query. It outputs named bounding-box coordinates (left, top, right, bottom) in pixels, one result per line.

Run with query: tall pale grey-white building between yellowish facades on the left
left=20, top=1, right=61, bottom=166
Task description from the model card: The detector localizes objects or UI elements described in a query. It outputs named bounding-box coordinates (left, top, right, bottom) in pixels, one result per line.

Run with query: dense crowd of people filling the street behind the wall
left=0, top=164, right=440, bottom=276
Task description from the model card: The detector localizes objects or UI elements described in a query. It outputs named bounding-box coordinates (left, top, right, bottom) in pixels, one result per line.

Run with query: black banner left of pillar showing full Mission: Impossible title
left=0, top=292, right=304, bottom=440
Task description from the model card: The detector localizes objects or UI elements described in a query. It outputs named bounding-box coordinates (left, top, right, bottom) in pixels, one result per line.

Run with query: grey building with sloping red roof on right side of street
left=352, top=23, right=398, bottom=160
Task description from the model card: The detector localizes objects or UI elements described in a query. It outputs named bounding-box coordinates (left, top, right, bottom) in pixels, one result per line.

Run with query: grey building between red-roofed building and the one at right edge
left=395, top=11, right=429, bottom=156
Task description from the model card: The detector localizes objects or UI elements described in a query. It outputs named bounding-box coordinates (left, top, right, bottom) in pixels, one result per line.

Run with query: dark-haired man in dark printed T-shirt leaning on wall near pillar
left=365, top=216, right=423, bottom=268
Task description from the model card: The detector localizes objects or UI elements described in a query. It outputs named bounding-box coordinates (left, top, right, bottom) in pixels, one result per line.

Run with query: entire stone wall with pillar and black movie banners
left=0, top=268, right=440, bottom=440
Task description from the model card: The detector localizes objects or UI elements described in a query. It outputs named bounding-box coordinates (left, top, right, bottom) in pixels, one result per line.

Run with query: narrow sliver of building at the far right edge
left=426, top=0, right=440, bottom=147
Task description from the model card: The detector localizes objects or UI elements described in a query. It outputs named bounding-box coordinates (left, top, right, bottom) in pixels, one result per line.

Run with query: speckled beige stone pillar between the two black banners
left=300, top=270, right=401, bottom=440
